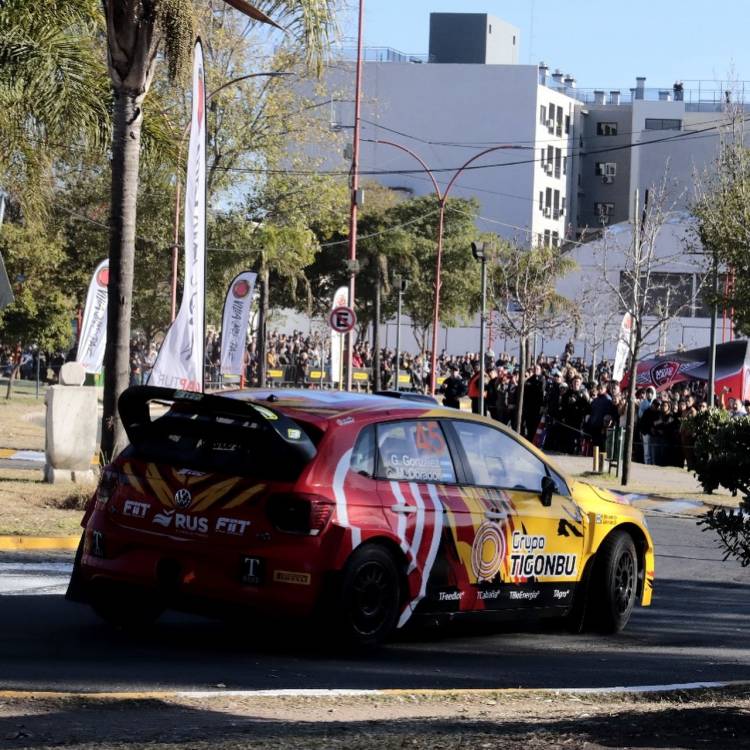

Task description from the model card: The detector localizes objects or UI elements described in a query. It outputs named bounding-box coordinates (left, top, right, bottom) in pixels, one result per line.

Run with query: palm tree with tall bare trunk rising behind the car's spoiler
left=101, top=0, right=333, bottom=457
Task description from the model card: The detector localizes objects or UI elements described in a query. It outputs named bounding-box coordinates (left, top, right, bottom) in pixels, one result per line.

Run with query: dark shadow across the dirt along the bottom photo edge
left=0, top=700, right=750, bottom=750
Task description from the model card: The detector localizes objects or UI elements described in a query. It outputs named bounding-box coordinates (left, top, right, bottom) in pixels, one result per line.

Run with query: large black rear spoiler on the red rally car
left=118, top=385, right=317, bottom=464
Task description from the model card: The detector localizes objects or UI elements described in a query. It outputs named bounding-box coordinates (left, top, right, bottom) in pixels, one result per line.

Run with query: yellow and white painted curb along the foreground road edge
left=0, top=680, right=750, bottom=700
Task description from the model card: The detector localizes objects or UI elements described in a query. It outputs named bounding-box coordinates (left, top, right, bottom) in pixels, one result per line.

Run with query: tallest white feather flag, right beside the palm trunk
left=149, top=39, right=206, bottom=391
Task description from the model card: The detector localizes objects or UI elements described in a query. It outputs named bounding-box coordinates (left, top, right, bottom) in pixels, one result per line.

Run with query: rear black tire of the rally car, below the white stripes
left=336, top=544, right=401, bottom=649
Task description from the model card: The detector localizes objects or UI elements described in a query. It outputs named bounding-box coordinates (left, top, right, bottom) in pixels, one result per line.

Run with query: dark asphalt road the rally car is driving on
left=0, top=516, right=750, bottom=690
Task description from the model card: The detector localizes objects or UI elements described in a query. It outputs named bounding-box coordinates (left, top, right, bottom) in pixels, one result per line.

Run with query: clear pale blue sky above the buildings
left=341, top=0, right=750, bottom=89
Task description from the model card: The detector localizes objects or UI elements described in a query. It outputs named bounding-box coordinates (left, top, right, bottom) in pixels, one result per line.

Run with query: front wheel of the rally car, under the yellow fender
left=588, top=531, right=638, bottom=633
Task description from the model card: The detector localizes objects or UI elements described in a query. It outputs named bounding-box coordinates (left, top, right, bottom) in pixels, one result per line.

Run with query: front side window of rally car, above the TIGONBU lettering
left=451, top=420, right=547, bottom=492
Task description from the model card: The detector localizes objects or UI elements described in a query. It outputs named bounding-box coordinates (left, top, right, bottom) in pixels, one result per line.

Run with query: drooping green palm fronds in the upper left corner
left=0, top=0, right=110, bottom=216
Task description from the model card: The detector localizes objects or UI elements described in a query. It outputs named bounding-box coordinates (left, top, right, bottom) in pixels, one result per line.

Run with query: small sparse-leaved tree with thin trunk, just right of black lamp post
left=488, top=238, right=578, bottom=432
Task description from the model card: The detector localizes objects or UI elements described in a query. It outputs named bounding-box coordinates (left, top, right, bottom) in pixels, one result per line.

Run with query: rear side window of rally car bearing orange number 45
left=377, top=420, right=456, bottom=484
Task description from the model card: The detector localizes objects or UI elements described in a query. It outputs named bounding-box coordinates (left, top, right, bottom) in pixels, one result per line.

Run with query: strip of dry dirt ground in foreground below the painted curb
left=0, top=690, right=750, bottom=750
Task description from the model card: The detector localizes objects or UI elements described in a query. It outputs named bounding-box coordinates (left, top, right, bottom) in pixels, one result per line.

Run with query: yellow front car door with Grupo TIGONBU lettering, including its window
left=445, top=420, right=584, bottom=609
